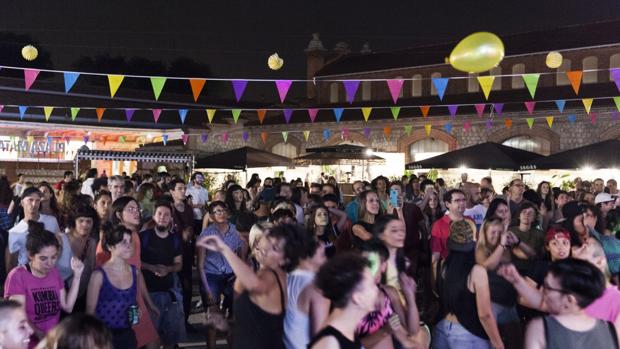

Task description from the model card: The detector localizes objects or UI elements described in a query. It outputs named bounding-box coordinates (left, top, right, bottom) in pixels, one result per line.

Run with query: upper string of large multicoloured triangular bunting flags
left=0, top=66, right=620, bottom=104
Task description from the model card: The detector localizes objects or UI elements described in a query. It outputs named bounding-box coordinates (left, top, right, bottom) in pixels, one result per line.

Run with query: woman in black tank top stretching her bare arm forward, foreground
left=196, top=225, right=311, bottom=349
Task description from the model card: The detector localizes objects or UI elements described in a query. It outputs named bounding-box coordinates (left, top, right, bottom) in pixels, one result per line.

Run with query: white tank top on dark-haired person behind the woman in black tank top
left=284, top=269, right=314, bottom=349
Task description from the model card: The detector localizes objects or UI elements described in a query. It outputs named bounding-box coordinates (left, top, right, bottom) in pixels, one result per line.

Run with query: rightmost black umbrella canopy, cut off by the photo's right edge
left=521, top=139, right=620, bottom=170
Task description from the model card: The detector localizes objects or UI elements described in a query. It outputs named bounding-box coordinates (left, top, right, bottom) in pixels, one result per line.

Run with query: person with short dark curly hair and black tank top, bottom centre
left=308, top=253, right=378, bottom=349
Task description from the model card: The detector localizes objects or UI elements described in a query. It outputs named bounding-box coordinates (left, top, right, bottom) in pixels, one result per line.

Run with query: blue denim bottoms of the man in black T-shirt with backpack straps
left=149, top=291, right=186, bottom=345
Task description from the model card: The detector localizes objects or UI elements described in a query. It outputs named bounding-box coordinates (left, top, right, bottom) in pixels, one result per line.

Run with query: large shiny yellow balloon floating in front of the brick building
left=447, top=32, right=504, bottom=73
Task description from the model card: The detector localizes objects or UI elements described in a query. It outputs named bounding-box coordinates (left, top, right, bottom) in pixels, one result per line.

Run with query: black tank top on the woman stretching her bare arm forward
left=233, top=270, right=284, bottom=349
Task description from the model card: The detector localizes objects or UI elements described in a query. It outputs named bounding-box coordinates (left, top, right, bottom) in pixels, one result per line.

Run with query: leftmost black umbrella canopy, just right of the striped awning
left=196, top=147, right=292, bottom=170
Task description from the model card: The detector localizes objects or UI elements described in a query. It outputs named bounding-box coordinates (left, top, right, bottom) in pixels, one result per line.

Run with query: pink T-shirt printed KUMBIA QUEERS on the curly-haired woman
left=4, top=266, right=64, bottom=347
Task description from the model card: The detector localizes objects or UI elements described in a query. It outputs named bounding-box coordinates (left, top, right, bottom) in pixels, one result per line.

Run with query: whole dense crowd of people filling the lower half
left=0, top=169, right=620, bottom=349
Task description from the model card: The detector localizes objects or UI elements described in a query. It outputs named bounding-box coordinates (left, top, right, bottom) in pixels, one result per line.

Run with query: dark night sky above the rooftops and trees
left=0, top=0, right=620, bottom=78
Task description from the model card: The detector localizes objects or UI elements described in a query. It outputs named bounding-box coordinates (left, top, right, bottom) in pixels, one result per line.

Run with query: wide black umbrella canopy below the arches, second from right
left=406, top=142, right=542, bottom=170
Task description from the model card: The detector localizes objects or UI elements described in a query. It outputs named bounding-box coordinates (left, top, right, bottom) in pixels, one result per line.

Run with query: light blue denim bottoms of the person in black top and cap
left=433, top=319, right=491, bottom=349
